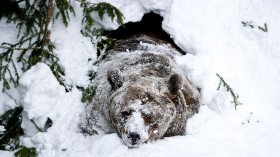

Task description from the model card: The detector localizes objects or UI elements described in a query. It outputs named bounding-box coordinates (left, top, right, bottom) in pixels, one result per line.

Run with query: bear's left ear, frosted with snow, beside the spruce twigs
left=107, top=68, right=123, bottom=90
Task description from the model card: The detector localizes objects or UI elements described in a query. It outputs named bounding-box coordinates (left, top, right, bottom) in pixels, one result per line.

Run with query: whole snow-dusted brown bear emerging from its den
left=92, top=37, right=200, bottom=147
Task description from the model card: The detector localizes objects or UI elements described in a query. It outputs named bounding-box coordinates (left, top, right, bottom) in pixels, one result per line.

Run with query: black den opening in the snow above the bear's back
left=106, top=12, right=186, bottom=54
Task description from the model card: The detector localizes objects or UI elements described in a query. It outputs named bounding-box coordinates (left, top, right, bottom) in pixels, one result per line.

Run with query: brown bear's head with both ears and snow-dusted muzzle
left=107, top=69, right=182, bottom=147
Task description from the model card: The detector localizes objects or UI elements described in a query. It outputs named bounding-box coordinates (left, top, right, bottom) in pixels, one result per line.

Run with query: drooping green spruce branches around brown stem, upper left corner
left=0, top=0, right=70, bottom=92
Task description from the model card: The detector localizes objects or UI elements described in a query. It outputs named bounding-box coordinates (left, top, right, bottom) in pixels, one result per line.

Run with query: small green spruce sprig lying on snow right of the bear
left=216, top=73, right=242, bottom=110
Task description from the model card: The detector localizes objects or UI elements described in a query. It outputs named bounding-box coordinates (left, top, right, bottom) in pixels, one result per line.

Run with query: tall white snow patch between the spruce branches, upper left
left=51, top=3, right=97, bottom=87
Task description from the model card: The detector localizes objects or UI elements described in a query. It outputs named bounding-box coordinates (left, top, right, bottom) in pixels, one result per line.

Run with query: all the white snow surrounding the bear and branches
left=0, top=0, right=280, bottom=157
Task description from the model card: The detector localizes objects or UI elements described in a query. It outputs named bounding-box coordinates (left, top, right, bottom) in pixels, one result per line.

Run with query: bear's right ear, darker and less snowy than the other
left=168, top=74, right=183, bottom=94
